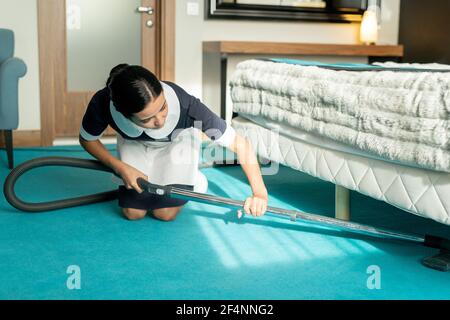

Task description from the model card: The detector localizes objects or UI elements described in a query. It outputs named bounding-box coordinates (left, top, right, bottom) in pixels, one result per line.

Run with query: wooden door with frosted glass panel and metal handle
left=37, top=0, right=175, bottom=145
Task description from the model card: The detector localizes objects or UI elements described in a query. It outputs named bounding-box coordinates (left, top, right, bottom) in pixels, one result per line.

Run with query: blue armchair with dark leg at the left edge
left=0, top=29, right=27, bottom=169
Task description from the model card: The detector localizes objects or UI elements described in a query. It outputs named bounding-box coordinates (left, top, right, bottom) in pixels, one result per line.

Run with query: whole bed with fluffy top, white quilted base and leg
left=230, top=59, right=450, bottom=225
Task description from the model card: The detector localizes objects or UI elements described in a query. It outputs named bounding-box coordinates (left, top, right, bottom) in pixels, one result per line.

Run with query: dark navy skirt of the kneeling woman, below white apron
left=119, top=184, right=194, bottom=210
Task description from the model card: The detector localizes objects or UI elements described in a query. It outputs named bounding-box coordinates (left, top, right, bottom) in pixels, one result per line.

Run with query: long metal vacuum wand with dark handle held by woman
left=138, top=178, right=450, bottom=250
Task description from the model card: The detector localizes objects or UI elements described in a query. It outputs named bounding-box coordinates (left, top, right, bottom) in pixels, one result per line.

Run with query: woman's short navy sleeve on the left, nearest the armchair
left=80, top=89, right=109, bottom=141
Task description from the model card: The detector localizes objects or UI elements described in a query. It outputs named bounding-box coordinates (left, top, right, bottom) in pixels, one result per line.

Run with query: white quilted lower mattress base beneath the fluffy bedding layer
left=232, top=117, right=450, bottom=225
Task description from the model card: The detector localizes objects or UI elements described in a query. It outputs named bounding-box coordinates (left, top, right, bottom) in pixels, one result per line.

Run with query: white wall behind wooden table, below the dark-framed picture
left=175, top=0, right=400, bottom=113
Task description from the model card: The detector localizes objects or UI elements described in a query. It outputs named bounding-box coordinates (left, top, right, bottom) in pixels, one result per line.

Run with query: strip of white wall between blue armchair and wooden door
left=0, top=0, right=41, bottom=130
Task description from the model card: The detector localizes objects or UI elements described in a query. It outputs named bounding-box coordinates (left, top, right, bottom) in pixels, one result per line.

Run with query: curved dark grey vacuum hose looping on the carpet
left=3, top=157, right=118, bottom=212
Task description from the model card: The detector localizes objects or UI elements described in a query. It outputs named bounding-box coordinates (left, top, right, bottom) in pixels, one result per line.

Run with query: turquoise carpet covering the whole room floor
left=0, top=146, right=450, bottom=299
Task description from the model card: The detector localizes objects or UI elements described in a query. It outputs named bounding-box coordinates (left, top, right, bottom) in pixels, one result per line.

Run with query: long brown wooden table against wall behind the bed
left=203, top=41, right=404, bottom=119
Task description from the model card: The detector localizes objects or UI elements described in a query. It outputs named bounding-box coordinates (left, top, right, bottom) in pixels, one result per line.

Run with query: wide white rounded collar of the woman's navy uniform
left=109, top=82, right=180, bottom=139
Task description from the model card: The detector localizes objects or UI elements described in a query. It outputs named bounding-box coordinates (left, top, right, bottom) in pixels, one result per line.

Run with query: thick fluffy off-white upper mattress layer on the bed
left=230, top=59, right=450, bottom=172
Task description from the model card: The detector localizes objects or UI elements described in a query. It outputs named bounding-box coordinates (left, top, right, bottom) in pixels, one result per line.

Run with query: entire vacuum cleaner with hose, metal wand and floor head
left=3, top=157, right=450, bottom=271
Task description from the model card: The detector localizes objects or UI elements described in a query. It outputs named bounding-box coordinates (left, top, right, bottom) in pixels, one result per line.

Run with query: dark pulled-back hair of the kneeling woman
left=106, top=63, right=162, bottom=118
